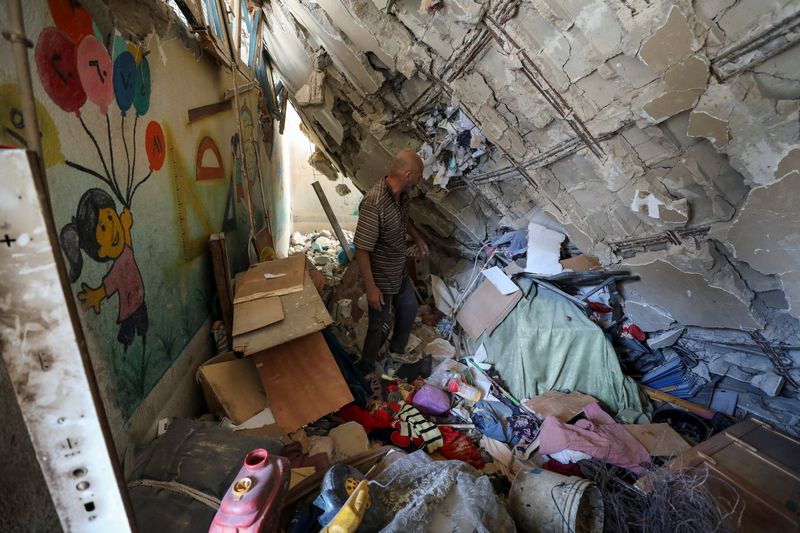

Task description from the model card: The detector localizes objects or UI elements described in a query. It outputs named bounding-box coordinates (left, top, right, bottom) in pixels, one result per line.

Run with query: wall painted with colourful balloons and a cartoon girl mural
left=0, top=1, right=289, bottom=432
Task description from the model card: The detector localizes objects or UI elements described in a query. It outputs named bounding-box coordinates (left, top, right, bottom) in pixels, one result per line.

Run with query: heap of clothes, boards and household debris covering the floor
left=130, top=227, right=800, bottom=532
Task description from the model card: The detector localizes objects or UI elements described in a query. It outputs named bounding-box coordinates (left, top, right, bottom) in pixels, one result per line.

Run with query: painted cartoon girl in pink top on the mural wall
left=60, top=188, right=148, bottom=351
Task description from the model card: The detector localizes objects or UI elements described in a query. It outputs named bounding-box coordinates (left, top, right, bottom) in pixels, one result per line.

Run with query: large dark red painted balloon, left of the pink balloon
left=36, top=28, right=86, bottom=113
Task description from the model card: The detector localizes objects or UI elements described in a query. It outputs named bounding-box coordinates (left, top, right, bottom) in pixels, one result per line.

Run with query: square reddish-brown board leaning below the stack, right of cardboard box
left=253, top=332, right=353, bottom=433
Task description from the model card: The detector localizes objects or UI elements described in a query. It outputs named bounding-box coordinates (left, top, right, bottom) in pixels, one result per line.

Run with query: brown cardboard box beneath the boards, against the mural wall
left=197, top=352, right=269, bottom=425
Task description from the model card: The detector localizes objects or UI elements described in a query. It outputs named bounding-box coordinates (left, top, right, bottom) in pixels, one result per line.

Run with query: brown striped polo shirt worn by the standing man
left=353, top=178, right=410, bottom=294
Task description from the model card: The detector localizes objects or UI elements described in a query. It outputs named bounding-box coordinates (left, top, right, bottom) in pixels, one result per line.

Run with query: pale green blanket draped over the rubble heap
left=470, top=279, right=650, bottom=421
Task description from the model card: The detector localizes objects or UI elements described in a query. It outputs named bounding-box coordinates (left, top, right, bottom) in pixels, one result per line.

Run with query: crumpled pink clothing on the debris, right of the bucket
left=539, top=402, right=650, bottom=474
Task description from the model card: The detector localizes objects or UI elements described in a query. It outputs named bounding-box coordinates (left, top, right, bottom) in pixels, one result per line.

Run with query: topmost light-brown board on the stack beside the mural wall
left=233, top=254, right=306, bottom=304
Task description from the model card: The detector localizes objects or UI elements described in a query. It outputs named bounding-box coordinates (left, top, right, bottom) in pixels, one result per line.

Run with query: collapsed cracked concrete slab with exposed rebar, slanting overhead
left=265, top=0, right=800, bottom=338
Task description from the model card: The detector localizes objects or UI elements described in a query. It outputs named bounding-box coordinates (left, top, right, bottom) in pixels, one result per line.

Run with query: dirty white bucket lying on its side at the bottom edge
left=509, top=468, right=603, bottom=533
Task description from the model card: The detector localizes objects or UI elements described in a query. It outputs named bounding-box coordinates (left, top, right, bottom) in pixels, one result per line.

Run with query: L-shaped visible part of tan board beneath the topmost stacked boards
left=233, top=273, right=333, bottom=355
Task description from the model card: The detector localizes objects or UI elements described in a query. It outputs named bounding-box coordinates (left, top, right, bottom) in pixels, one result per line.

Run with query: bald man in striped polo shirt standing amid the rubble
left=353, top=150, right=428, bottom=368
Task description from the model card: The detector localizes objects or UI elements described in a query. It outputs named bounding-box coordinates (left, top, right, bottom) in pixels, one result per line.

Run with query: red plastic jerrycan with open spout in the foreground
left=208, top=448, right=291, bottom=533
